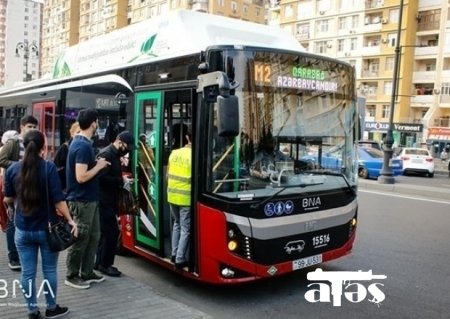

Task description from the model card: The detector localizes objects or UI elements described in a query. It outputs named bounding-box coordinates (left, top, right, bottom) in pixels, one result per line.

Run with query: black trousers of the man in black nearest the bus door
left=95, top=201, right=120, bottom=268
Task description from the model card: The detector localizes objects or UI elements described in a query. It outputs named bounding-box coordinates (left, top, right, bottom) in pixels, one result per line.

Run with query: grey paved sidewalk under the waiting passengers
left=0, top=238, right=212, bottom=319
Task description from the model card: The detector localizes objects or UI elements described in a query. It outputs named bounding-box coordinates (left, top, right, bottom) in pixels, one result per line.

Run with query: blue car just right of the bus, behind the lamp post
left=358, top=147, right=403, bottom=179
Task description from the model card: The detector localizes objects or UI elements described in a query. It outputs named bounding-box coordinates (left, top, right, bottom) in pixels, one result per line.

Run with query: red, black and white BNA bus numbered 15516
left=0, top=11, right=359, bottom=284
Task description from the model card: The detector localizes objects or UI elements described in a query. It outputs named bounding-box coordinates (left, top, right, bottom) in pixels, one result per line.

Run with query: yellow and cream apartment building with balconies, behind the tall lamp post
left=268, top=0, right=450, bottom=148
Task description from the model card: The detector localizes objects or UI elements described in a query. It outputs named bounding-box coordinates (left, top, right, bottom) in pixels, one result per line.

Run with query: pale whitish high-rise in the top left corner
left=0, top=0, right=42, bottom=86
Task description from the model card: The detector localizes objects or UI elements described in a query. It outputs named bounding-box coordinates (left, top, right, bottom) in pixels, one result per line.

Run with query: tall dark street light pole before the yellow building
left=378, top=0, right=403, bottom=184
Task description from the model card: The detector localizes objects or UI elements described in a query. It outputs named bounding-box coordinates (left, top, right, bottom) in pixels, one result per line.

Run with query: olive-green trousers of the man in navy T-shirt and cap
left=66, top=201, right=100, bottom=278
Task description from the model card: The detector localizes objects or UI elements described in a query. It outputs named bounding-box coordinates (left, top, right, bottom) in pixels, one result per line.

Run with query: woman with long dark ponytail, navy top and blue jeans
left=4, top=130, right=78, bottom=318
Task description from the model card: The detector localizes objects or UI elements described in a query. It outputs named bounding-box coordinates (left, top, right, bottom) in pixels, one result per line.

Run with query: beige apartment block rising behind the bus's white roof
left=42, top=0, right=264, bottom=74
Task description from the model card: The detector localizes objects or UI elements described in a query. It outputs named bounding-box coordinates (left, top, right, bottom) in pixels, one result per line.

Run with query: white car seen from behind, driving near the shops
left=398, top=147, right=434, bottom=177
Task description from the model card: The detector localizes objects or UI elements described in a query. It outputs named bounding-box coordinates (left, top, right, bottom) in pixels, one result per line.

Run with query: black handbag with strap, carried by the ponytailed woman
left=45, top=162, right=76, bottom=252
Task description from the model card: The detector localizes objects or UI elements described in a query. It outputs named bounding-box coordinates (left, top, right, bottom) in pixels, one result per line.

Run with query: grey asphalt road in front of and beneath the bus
left=113, top=177, right=450, bottom=319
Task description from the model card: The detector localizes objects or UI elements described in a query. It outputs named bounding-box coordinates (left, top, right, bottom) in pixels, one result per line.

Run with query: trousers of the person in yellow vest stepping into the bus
left=170, top=204, right=191, bottom=264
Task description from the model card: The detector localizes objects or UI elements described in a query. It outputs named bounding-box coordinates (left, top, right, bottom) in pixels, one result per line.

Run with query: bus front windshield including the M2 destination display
left=206, top=50, right=357, bottom=198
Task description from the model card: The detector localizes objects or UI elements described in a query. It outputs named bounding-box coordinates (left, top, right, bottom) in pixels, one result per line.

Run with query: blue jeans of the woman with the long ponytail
left=15, top=229, right=59, bottom=313
